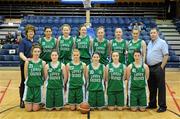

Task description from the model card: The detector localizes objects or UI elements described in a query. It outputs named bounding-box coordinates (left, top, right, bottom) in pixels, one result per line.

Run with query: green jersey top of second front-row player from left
left=47, top=62, right=64, bottom=89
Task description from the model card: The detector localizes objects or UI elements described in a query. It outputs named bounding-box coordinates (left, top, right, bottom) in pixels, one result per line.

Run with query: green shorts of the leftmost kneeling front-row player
left=23, top=86, right=43, bottom=104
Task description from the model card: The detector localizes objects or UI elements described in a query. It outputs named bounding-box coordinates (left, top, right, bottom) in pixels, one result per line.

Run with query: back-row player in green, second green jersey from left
left=58, top=24, right=74, bottom=65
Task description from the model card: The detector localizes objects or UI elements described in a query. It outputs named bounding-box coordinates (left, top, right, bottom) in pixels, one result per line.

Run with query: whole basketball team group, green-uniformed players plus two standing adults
left=19, top=24, right=168, bottom=112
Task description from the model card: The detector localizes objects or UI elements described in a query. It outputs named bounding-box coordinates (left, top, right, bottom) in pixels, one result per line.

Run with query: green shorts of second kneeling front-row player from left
left=46, top=88, right=64, bottom=109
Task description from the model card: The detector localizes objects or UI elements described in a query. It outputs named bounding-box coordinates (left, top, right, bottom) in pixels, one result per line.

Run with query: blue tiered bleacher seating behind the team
left=0, top=16, right=180, bottom=68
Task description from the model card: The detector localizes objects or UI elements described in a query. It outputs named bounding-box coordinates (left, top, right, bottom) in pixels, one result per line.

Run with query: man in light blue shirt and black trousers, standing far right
left=147, top=28, right=169, bottom=112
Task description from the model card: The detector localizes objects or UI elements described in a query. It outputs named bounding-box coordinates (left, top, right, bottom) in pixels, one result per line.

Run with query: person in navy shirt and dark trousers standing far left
left=19, top=25, right=38, bottom=108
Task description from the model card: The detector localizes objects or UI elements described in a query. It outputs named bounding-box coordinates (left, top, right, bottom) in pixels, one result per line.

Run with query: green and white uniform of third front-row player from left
left=67, top=61, right=85, bottom=104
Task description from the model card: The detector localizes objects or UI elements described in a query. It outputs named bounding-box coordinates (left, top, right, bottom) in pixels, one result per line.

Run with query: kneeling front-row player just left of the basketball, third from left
left=66, top=49, right=86, bottom=111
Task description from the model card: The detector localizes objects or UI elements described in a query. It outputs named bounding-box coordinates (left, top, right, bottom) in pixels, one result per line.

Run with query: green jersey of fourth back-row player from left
left=93, top=38, right=109, bottom=65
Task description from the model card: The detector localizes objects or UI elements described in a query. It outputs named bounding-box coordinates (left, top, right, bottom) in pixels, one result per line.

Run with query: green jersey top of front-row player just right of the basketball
left=87, top=64, right=104, bottom=91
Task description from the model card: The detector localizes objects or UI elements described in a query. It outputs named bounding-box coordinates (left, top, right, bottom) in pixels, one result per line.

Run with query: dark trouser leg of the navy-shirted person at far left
left=19, top=63, right=25, bottom=101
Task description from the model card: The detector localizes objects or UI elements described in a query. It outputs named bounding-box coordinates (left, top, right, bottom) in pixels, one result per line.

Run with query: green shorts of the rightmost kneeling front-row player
left=128, top=88, right=147, bottom=107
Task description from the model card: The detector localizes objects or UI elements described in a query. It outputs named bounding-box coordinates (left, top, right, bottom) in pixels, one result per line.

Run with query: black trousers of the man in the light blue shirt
left=148, top=63, right=167, bottom=109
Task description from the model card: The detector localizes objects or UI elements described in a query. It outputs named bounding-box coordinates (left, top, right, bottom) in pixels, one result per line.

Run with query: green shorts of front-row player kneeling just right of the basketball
left=87, top=90, right=105, bottom=108
